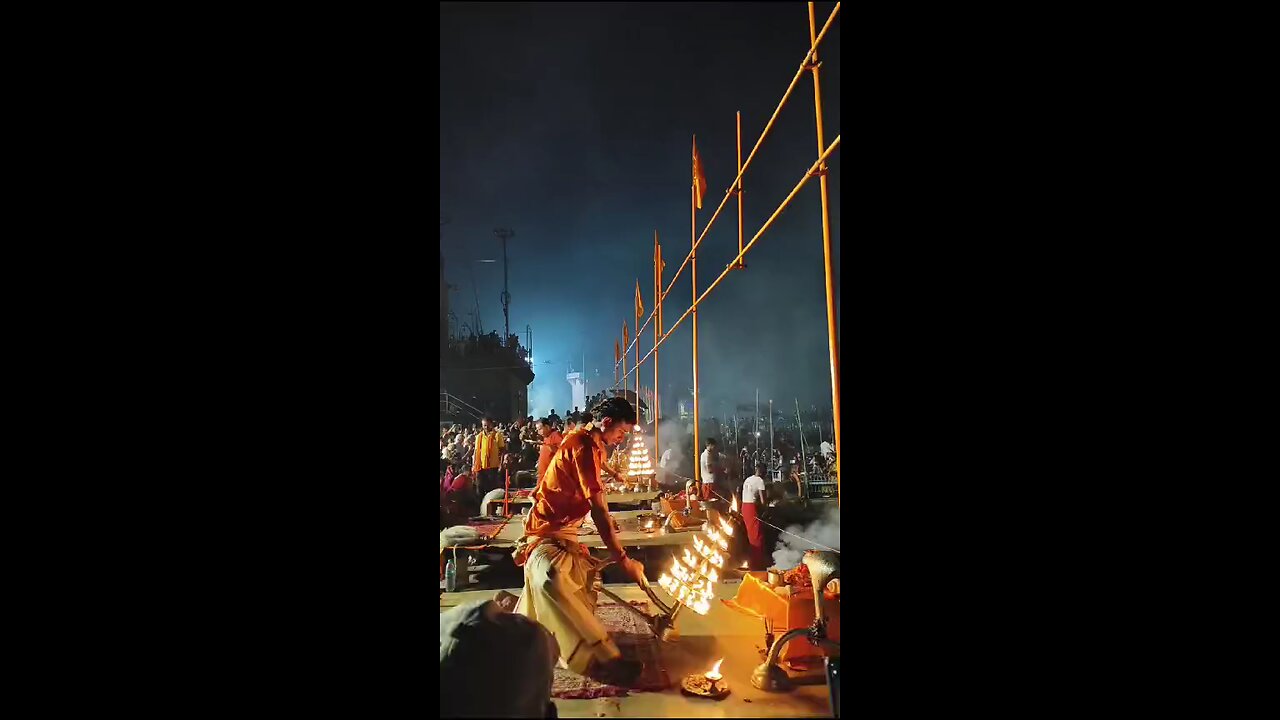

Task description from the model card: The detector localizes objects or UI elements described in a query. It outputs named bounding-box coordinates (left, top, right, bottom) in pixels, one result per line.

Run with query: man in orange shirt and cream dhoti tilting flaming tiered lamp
left=515, top=397, right=644, bottom=685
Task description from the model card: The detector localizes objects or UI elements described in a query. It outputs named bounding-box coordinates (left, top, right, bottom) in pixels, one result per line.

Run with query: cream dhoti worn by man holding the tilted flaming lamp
left=516, top=528, right=621, bottom=675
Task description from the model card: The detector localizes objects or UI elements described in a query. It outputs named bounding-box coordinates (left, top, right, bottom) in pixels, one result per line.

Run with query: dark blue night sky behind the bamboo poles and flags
left=440, top=3, right=847, bottom=416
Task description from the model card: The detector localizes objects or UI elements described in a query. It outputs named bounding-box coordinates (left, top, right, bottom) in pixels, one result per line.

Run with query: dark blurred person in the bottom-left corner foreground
left=440, top=600, right=557, bottom=717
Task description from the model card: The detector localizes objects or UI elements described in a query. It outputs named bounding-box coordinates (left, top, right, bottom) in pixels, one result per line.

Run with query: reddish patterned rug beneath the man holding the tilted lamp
left=552, top=600, right=671, bottom=700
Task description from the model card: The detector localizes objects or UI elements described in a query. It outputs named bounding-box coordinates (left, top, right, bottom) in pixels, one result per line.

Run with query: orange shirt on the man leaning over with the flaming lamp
left=525, top=425, right=605, bottom=556
